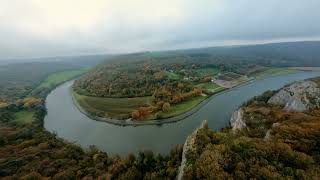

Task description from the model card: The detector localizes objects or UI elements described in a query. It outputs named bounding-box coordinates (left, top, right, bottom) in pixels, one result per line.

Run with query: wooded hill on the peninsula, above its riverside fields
left=74, top=53, right=262, bottom=97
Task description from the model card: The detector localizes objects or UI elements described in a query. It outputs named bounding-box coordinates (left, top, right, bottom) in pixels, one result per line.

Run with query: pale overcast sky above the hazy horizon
left=0, top=0, right=320, bottom=59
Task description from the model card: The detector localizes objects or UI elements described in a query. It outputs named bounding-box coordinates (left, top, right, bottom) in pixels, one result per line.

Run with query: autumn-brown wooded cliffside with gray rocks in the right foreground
left=183, top=78, right=320, bottom=179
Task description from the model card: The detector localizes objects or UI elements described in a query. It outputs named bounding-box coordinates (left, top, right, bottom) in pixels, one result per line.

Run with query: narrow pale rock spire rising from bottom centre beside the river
left=177, top=120, right=208, bottom=180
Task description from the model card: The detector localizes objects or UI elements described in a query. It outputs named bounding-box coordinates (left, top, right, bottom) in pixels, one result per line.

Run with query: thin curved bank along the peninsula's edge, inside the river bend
left=69, top=78, right=255, bottom=126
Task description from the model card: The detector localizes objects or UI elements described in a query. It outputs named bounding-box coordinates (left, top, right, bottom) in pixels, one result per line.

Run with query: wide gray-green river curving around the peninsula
left=44, top=72, right=320, bottom=155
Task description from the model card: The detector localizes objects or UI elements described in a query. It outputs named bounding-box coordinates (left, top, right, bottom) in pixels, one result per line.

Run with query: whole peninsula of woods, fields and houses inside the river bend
left=73, top=52, right=266, bottom=120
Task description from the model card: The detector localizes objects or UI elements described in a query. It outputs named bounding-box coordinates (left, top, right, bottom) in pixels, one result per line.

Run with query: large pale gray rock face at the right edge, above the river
left=268, top=81, right=320, bottom=112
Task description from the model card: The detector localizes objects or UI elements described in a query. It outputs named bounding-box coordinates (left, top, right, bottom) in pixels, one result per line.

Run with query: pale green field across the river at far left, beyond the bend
left=35, top=68, right=89, bottom=91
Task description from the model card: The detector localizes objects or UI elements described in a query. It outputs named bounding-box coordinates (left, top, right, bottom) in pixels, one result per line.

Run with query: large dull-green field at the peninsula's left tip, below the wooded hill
left=73, top=92, right=152, bottom=119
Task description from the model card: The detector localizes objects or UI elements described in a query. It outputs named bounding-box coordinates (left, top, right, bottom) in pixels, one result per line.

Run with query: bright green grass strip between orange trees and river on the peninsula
left=156, top=96, right=206, bottom=118
